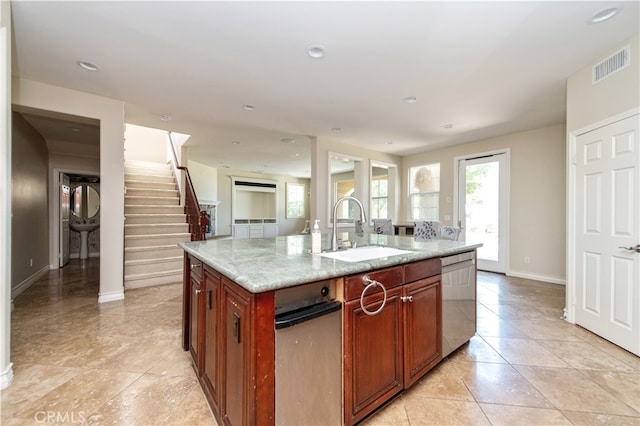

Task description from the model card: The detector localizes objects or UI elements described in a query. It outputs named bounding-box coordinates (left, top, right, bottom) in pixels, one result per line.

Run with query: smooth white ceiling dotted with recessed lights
left=12, top=1, right=639, bottom=176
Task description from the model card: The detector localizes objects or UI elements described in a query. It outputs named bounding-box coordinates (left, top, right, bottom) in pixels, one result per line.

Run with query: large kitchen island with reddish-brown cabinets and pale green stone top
left=180, top=233, right=479, bottom=425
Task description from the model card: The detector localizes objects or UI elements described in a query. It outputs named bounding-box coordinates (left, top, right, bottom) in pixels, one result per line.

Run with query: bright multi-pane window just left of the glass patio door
left=409, top=163, right=440, bottom=220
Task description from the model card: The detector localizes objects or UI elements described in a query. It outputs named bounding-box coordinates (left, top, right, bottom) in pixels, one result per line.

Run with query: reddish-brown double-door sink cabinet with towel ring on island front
left=343, top=259, right=442, bottom=425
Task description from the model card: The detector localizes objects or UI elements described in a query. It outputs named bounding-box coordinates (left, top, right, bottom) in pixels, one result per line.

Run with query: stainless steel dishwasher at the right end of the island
left=441, top=251, right=476, bottom=358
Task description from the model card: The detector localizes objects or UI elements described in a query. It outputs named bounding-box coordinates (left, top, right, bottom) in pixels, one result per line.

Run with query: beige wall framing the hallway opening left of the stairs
left=12, top=79, right=125, bottom=302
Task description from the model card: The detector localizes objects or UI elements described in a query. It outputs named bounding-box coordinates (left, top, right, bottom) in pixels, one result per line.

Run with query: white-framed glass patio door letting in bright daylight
left=457, top=152, right=509, bottom=273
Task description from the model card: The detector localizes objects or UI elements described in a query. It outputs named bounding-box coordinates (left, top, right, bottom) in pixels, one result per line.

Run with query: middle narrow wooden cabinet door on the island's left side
left=202, top=267, right=220, bottom=411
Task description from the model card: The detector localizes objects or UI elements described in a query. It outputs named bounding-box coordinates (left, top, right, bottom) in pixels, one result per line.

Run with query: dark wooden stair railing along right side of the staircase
left=168, top=131, right=209, bottom=241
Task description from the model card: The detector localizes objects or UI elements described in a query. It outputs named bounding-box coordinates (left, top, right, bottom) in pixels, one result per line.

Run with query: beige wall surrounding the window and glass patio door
left=402, top=124, right=565, bottom=283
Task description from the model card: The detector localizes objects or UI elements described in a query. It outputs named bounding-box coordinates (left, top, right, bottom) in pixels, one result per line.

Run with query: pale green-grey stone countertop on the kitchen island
left=178, top=232, right=481, bottom=293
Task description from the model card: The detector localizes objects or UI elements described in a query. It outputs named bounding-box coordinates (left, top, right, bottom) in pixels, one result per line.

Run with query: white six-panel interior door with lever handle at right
left=573, top=115, right=640, bottom=355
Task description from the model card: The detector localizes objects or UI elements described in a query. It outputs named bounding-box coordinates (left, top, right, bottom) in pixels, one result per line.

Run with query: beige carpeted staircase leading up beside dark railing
left=124, top=161, right=191, bottom=290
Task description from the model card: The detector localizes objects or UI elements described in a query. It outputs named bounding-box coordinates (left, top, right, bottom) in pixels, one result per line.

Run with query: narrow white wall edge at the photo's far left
left=0, top=1, right=13, bottom=389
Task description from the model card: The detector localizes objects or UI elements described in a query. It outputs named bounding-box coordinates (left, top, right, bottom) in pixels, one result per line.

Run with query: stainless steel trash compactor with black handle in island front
left=275, top=281, right=342, bottom=426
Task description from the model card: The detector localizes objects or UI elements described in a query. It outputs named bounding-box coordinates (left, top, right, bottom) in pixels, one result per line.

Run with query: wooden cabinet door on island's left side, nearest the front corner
left=220, top=279, right=253, bottom=425
